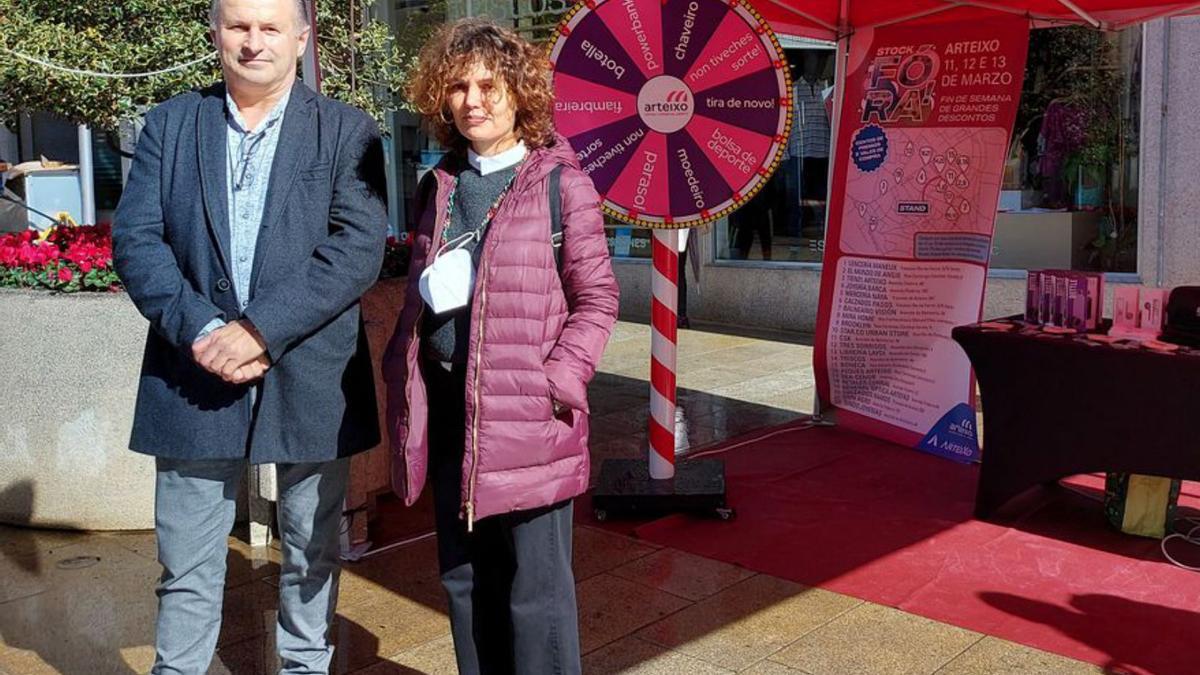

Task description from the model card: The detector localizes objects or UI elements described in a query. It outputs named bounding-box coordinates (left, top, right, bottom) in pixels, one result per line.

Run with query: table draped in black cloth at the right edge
left=953, top=319, right=1200, bottom=518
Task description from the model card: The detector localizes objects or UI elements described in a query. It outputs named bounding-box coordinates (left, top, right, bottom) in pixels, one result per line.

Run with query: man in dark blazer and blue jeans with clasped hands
left=113, top=0, right=386, bottom=673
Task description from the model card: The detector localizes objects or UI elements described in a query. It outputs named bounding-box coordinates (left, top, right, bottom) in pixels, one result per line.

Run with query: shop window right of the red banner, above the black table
left=991, top=28, right=1141, bottom=273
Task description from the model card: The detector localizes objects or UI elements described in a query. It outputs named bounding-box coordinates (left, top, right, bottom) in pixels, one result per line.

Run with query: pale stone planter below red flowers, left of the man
left=0, top=289, right=154, bottom=530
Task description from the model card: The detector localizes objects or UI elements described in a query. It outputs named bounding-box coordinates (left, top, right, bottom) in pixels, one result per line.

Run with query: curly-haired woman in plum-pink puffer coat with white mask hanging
left=384, top=19, right=618, bottom=674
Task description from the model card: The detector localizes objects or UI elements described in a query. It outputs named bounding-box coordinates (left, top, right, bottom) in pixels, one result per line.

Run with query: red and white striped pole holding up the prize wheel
left=649, top=229, right=679, bottom=480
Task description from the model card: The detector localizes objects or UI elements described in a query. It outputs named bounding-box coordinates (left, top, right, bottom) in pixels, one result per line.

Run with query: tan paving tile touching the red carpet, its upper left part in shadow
left=637, top=575, right=862, bottom=670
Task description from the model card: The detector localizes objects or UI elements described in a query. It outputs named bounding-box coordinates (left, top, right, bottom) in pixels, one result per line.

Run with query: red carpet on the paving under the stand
left=637, top=420, right=1200, bottom=674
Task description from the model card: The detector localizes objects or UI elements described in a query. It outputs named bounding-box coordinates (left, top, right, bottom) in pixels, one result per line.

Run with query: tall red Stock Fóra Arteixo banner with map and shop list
left=815, top=17, right=1028, bottom=461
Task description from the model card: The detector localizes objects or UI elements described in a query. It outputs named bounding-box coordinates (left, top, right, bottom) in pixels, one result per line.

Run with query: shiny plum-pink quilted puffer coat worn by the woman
left=383, top=137, right=619, bottom=525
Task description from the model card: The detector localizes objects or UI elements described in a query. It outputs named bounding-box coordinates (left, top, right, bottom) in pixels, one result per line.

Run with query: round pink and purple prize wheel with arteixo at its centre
left=550, top=0, right=792, bottom=228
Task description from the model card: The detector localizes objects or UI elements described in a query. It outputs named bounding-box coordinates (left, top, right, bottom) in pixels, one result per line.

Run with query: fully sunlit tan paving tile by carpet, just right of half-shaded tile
left=770, top=603, right=983, bottom=675
